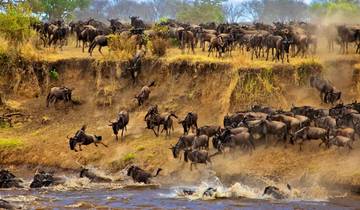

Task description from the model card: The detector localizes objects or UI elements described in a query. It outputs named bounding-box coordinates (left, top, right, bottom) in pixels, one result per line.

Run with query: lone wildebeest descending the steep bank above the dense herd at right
left=310, top=76, right=341, bottom=103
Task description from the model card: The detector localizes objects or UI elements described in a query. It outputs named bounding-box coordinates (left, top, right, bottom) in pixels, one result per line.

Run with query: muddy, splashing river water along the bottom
left=0, top=171, right=360, bottom=210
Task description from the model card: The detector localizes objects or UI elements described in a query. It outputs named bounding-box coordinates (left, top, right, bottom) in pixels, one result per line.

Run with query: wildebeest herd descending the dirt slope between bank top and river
left=43, top=69, right=360, bottom=175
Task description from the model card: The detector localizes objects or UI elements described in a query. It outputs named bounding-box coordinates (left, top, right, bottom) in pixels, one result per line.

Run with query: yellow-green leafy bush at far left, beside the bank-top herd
left=0, top=3, right=31, bottom=50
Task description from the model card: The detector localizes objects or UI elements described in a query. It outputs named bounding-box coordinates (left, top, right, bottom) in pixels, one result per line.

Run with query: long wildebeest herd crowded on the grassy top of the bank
left=32, top=16, right=360, bottom=62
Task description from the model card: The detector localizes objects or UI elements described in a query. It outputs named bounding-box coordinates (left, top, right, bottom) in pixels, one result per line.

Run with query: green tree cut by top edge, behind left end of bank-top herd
left=29, top=0, right=91, bottom=20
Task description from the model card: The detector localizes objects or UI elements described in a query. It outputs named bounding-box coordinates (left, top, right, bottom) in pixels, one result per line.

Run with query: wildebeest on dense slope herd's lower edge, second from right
left=290, top=126, right=329, bottom=151
